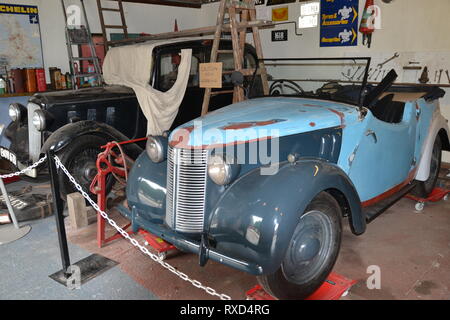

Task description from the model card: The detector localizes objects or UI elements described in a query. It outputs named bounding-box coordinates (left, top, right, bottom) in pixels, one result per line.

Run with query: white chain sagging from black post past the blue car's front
left=55, top=156, right=231, bottom=300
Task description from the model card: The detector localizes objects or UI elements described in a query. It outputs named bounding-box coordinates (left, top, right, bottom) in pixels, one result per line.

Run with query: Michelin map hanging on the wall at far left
left=0, top=3, right=43, bottom=68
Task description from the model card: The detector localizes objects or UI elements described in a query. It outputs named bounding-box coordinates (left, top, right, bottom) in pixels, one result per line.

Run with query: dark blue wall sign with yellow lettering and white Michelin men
left=320, top=0, right=359, bottom=47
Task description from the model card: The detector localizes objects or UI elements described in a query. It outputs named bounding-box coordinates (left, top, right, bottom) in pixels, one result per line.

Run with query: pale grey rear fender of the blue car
left=415, top=108, right=450, bottom=181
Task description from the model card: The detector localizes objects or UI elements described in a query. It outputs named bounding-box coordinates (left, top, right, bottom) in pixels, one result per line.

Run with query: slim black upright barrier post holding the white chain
left=47, top=148, right=70, bottom=276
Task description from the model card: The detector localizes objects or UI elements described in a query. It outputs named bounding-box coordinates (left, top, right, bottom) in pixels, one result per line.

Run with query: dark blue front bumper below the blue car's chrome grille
left=118, top=206, right=263, bottom=275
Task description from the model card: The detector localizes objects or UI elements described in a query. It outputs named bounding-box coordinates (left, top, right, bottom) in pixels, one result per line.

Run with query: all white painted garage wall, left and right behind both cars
left=5, top=0, right=450, bottom=162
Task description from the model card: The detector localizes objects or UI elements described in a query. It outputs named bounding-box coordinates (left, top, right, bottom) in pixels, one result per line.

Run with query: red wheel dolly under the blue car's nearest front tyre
left=246, top=272, right=357, bottom=300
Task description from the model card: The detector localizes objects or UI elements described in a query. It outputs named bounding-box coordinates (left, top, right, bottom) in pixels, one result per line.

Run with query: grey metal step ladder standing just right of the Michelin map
left=61, top=0, right=103, bottom=89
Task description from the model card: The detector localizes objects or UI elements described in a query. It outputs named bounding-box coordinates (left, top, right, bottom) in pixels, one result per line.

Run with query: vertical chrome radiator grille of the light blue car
left=166, top=147, right=208, bottom=233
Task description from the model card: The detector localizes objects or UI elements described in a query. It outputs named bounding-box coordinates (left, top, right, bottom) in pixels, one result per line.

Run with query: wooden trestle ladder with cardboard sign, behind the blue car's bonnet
left=202, top=0, right=269, bottom=115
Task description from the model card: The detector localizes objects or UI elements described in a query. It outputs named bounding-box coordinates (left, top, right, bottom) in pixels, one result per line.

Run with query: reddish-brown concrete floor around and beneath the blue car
left=68, top=195, right=450, bottom=300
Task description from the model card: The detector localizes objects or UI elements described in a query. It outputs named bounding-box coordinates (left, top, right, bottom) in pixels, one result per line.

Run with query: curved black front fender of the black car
left=41, top=120, right=142, bottom=159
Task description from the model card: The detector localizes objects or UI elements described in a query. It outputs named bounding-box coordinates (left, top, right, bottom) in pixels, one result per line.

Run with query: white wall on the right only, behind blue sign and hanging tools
left=202, top=0, right=450, bottom=162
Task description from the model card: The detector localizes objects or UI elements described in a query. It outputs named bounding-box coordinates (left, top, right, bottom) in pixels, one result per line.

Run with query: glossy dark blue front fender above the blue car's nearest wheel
left=208, top=159, right=366, bottom=274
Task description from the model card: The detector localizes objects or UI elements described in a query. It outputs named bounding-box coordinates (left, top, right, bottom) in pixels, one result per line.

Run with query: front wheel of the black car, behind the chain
left=58, top=135, right=114, bottom=201
